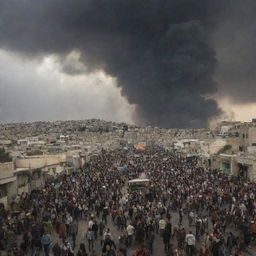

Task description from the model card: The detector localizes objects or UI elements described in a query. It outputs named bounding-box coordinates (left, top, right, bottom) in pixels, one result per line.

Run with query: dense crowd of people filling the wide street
left=0, top=148, right=256, bottom=256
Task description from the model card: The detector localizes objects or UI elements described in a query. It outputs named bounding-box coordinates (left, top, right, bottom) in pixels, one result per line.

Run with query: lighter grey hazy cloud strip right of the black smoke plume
left=212, top=0, right=256, bottom=104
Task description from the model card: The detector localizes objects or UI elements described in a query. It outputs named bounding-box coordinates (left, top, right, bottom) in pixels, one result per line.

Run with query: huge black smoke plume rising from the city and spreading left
left=0, top=0, right=232, bottom=127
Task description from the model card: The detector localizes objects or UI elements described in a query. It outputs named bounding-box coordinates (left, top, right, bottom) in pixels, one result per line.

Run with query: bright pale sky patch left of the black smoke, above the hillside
left=0, top=50, right=133, bottom=123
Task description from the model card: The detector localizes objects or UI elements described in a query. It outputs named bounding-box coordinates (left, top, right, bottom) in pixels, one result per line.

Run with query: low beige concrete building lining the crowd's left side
left=0, top=154, right=73, bottom=207
